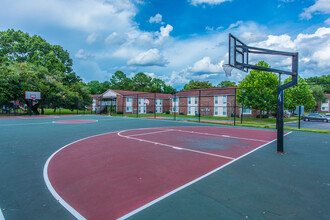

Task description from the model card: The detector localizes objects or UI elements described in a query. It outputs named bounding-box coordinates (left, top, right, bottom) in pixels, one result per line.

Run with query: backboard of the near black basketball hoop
left=228, top=34, right=249, bottom=72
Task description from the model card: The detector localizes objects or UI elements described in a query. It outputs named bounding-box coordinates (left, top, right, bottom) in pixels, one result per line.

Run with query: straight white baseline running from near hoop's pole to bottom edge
left=117, top=132, right=292, bottom=220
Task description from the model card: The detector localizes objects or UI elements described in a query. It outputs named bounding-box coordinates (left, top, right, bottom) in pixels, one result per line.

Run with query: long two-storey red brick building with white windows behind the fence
left=93, top=87, right=259, bottom=117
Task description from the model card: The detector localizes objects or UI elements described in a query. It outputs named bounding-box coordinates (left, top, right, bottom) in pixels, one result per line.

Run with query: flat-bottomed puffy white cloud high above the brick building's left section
left=127, top=48, right=168, bottom=66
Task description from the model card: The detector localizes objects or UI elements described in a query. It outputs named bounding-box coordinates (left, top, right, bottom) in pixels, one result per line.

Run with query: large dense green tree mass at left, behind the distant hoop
left=0, top=29, right=91, bottom=113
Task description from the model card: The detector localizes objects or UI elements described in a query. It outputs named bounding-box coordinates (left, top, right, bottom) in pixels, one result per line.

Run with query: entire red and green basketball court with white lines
left=0, top=115, right=330, bottom=219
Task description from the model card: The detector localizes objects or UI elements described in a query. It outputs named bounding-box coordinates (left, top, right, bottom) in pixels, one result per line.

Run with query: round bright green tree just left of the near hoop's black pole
left=237, top=61, right=278, bottom=118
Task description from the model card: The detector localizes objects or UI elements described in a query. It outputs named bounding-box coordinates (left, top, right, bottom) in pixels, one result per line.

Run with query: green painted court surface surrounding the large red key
left=0, top=116, right=330, bottom=220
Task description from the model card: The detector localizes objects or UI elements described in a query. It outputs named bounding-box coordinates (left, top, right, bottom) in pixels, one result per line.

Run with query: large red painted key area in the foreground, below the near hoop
left=45, top=127, right=276, bottom=219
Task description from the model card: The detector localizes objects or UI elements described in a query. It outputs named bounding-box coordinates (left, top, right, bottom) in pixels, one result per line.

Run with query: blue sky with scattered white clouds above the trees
left=0, top=0, right=330, bottom=89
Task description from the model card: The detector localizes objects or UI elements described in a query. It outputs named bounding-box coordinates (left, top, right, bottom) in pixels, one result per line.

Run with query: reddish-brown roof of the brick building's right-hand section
left=176, top=87, right=237, bottom=97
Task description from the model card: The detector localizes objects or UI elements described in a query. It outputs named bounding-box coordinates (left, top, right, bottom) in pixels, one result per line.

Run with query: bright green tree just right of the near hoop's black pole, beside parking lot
left=284, top=77, right=316, bottom=112
